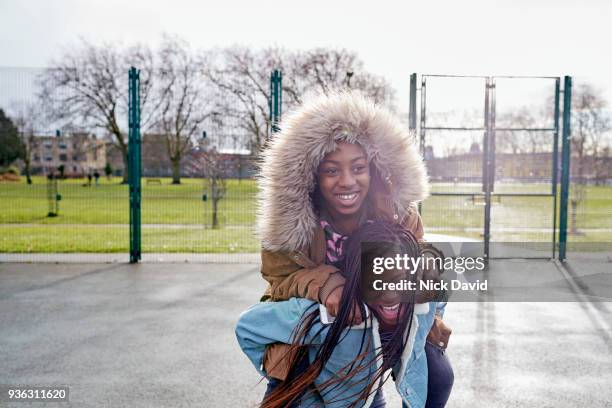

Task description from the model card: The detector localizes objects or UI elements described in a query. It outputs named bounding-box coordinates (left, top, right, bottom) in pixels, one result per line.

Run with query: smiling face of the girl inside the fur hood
left=318, top=142, right=370, bottom=222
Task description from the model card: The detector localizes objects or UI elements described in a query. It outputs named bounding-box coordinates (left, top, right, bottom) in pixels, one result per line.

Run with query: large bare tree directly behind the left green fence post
left=41, top=41, right=156, bottom=183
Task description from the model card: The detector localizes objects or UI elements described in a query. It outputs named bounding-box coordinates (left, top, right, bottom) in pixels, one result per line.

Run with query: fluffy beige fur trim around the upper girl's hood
left=257, top=92, right=429, bottom=251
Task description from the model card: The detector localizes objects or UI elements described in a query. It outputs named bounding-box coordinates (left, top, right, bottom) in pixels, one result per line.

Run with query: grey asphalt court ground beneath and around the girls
left=0, top=260, right=612, bottom=407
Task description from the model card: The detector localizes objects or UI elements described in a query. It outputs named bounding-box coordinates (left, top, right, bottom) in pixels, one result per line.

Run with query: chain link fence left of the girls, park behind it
left=0, top=68, right=262, bottom=262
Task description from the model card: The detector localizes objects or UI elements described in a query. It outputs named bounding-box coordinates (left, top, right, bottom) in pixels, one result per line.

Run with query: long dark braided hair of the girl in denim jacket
left=261, top=220, right=420, bottom=408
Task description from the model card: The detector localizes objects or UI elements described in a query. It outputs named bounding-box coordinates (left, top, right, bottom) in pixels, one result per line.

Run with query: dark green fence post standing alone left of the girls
left=128, top=67, right=141, bottom=263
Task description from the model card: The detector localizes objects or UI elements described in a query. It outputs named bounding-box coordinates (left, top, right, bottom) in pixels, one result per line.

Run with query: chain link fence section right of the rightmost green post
left=567, top=76, right=612, bottom=262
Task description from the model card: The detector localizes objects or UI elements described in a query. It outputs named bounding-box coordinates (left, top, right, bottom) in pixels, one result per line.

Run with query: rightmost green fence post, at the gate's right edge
left=559, top=76, right=572, bottom=261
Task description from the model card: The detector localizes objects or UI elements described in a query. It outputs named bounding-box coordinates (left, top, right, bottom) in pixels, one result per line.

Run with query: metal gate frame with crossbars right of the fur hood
left=409, top=73, right=571, bottom=261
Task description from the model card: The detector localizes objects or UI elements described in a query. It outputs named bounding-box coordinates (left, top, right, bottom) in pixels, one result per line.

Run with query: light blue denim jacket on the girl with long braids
left=236, top=298, right=438, bottom=407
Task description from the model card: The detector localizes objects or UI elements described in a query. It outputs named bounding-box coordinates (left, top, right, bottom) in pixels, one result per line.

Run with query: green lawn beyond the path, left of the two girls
left=0, top=177, right=256, bottom=225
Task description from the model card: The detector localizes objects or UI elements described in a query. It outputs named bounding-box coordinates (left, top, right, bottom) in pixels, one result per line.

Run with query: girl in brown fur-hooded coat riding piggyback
left=246, top=92, right=452, bottom=406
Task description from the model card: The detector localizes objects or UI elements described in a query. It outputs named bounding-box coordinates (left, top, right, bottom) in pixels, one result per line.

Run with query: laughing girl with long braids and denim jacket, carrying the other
left=236, top=221, right=444, bottom=408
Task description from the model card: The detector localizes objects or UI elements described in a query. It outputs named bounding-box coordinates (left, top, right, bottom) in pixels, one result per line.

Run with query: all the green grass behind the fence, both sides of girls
left=0, top=177, right=612, bottom=253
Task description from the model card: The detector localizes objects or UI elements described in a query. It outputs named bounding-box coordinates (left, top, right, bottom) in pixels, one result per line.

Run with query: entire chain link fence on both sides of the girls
left=0, top=68, right=612, bottom=261
